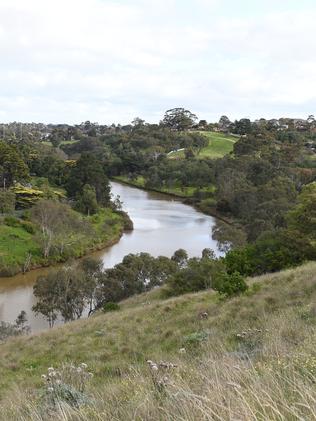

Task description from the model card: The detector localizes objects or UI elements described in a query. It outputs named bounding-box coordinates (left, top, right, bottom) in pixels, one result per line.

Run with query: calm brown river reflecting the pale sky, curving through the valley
left=0, top=182, right=219, bottom=332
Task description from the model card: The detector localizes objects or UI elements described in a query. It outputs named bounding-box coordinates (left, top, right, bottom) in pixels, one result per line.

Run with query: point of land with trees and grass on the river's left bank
left=0, top=141, right=132, bottom=276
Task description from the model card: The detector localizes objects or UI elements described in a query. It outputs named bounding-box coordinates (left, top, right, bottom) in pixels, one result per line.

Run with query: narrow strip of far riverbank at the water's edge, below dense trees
left=112, top=176, right=236, bottom=225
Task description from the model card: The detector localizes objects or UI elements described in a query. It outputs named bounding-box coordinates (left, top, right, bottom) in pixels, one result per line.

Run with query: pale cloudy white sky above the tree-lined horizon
left=0, top=0, right=316, bottom=124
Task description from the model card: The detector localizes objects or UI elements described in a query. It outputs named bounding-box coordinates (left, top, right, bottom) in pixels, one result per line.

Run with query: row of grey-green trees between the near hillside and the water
left=33, top=249, right=247, bottom=327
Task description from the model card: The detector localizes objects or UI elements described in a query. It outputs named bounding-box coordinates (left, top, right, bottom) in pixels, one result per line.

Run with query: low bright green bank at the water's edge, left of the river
left=0, top=209, right=133, bottom=279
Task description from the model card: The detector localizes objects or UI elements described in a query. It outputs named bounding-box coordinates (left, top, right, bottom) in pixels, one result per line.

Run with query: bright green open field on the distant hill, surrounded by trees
left=169, top=132, right=238, bottom=159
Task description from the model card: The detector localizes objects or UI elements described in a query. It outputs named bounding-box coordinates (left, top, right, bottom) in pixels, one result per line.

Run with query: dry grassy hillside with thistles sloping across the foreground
left=0, top=263, right=316, bottom=420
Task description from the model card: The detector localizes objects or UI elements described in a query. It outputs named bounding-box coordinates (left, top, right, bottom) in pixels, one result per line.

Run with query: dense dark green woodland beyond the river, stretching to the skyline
left=0, top=108, right=316, bottom=273
